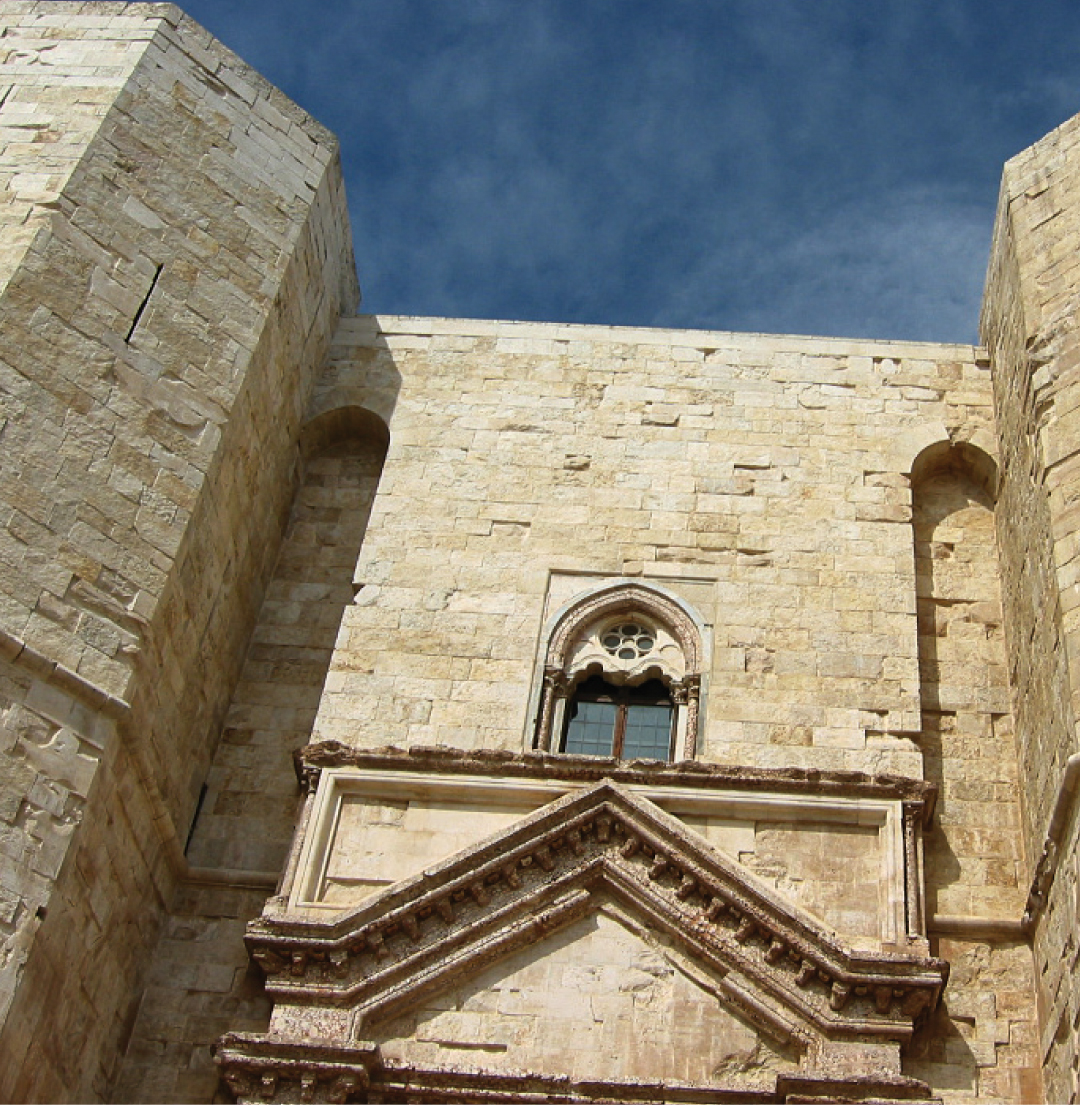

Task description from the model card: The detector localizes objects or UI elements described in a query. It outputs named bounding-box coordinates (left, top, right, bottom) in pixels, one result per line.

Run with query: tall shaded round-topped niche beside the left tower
left=188, top=408, right=389, bottom=874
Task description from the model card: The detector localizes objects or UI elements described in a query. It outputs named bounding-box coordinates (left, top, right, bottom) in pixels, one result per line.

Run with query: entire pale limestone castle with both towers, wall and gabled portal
left=0, top=0, right=1080, bottom=1103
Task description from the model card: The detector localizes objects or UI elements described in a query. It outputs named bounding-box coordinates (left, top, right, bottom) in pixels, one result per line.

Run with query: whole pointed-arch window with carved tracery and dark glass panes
left=534, top=585, right=702, bottom=760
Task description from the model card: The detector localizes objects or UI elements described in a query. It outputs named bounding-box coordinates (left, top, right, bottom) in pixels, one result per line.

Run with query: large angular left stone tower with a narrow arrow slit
left=0, top=2, right=357, bottom=1099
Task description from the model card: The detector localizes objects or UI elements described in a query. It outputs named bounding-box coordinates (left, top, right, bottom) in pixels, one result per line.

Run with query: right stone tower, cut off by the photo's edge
left=982, top=118, right=1080, bottom=1101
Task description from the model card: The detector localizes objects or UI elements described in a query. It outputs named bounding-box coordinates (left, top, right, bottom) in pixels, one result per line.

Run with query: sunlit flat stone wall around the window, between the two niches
left=316, top=318, right=986, bottom=774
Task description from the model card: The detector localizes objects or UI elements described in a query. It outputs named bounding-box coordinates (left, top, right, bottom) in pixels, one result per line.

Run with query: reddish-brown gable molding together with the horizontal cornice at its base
left=225, top=782, right=948, bottom=1105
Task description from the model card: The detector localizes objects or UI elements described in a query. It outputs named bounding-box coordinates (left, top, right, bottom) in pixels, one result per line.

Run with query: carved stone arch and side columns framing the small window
left=532, top=581, right=705, bottom=762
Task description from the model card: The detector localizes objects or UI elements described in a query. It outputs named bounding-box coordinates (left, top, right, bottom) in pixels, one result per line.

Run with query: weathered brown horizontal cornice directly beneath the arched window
left=293, top=740, right=937, bottom=825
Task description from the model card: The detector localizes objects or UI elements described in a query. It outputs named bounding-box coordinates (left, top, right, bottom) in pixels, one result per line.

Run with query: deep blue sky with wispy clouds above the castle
left=181, top=0, right=1080, bottom=341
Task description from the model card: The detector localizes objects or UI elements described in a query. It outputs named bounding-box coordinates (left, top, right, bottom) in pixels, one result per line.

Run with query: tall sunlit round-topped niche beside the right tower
left=912, top=446, right=1021, bottom=916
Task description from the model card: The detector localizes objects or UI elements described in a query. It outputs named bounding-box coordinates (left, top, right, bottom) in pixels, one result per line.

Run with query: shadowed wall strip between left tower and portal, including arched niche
left=113, top=319, right=400, bottom=1102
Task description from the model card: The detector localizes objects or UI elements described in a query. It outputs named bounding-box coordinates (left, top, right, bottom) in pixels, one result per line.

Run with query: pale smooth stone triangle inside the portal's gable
left=371, top=894, right=803, bottom=1091
